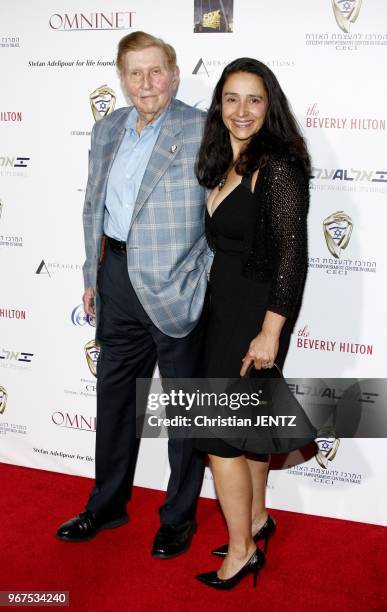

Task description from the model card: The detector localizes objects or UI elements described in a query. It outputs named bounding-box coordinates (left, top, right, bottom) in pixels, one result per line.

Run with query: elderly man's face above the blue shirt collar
left=121, top=47, right=179, bottom=121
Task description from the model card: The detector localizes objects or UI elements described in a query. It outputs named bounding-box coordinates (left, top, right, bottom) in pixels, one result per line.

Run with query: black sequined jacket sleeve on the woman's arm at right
left=266, top=158, right=309, bottom=317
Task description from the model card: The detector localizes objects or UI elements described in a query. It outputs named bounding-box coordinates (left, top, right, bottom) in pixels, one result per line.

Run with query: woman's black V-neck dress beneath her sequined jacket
left=195, top=176, right=289, bottom=461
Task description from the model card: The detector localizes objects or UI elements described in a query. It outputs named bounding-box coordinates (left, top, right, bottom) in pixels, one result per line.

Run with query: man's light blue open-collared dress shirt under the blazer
left=104, top=108, right=165, bottom=242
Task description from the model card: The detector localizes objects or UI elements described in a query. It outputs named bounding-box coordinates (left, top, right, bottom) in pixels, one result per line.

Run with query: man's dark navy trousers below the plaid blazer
left=87, top=243, right=206, bottom=525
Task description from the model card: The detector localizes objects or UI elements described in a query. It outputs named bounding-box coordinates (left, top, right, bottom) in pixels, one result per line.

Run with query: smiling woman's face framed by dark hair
left=222, top=72, right=268, bottom=146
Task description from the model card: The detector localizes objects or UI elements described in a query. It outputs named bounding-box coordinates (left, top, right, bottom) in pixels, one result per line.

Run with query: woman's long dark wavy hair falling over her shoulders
left=195, top=57, right=310, bottom=188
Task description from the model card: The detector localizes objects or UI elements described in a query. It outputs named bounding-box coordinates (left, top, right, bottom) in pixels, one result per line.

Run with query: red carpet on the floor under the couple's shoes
left=0, top=464, right=387, bottom=612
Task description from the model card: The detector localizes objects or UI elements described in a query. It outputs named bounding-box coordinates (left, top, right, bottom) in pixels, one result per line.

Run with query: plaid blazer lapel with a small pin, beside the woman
left=130, top=99, right=182, bottom=227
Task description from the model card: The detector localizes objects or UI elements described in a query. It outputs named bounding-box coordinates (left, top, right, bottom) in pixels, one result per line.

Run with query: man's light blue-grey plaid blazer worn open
left=83, top=99, right=212, bottom=338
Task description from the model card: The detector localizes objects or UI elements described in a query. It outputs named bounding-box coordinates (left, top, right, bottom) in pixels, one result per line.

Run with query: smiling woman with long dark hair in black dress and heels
left=196, top=58, right=310, bottom=589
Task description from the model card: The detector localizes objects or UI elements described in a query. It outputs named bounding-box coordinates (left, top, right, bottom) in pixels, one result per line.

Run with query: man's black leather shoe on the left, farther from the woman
left=55, top=510, right=129, bottom=542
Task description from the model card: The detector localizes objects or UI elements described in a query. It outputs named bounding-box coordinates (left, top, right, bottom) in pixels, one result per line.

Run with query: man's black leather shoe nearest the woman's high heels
left=152, top=521, right=197, bottom=559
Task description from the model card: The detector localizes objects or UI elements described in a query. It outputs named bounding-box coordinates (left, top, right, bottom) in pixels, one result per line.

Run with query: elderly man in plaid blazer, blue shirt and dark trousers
left=57, top=32, right=211, bottom=558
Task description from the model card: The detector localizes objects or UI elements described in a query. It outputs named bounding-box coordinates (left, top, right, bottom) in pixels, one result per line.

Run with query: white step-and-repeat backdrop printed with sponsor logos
left=0, top=0, right=387, bottom=524
